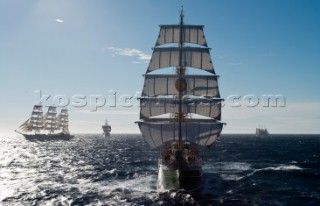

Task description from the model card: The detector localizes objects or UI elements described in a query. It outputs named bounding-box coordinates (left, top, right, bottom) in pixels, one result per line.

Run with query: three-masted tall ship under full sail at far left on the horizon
left=15, top=105, right=73, bottom=140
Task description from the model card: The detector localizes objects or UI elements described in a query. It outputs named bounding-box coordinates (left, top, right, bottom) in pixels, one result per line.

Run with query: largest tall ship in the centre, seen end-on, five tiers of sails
left=136, top=10, right=224, bottom=190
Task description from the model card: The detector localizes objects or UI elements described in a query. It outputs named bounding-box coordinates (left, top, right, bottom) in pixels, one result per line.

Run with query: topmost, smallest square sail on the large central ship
left=156, top=25, right=207, bottom=46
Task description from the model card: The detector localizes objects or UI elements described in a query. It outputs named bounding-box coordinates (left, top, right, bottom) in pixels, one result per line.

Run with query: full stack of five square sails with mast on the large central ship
left=137, top=15, right=223, bottom=147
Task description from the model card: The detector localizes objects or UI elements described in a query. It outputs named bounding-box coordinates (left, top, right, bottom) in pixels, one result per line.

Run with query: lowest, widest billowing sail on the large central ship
left=138, top=119, right=222, bottom=147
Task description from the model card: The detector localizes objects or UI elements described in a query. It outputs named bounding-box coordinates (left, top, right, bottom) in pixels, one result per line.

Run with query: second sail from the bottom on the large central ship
left=140, top=98, right=221, bottom=120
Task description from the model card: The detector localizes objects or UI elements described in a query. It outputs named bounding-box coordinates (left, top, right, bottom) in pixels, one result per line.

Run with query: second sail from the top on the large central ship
left=147, top=47, right=214, bottom=73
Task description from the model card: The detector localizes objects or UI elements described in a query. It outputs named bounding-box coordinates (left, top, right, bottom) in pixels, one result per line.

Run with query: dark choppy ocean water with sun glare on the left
left=0, top=134, right=320, bottom=206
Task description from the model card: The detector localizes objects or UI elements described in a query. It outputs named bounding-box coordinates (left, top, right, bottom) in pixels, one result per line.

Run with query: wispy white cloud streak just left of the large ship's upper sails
left=104, top=47, right=151, bottom=64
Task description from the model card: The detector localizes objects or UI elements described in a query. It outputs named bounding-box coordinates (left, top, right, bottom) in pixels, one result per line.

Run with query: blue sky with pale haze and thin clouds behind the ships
left=0, top=0, right=320, bottom=134
